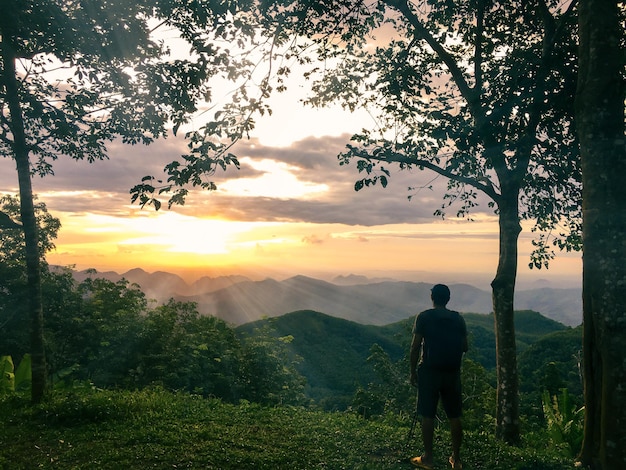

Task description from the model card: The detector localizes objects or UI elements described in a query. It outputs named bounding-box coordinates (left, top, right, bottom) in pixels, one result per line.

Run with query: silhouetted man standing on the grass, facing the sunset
left=411, top=284, right=467, bottom=470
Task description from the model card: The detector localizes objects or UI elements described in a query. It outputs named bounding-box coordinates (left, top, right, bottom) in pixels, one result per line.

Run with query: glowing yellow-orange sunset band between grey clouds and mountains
left=39, top=202, right=580, bottom=287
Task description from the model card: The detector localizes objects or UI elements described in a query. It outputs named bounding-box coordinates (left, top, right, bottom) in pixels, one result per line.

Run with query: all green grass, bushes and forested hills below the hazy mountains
left=0, top=272, right=581, bottom=470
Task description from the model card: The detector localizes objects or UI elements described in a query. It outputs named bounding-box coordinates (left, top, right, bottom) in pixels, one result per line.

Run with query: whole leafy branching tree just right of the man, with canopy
left=258, top=0, right=580, bottom=443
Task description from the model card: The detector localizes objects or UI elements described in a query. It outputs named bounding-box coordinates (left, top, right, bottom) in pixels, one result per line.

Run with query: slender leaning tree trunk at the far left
left=2, top=40, right=46, bottom=403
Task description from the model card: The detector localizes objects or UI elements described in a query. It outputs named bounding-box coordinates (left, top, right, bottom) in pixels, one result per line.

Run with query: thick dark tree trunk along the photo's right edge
left=576, top=0, right=626, bottom=470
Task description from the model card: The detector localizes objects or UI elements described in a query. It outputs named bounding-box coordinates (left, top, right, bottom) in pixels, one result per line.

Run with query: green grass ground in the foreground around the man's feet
left=0, top=390, right=574, bottom=470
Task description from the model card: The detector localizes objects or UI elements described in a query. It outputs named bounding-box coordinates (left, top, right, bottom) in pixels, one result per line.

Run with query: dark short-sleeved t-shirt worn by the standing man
left=413, top=308, right=467, bottom=371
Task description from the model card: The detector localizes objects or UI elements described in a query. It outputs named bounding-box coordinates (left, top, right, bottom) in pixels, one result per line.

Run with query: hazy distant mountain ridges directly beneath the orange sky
left=74, top=268, right=582, bottom=326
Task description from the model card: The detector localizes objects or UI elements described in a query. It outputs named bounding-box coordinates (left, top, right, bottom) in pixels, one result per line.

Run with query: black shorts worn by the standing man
left=417, top=365, right=463, bottom=419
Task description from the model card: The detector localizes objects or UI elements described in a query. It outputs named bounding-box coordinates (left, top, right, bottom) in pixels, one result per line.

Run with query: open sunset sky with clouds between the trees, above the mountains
left=0, top=35, right=582, bottom=289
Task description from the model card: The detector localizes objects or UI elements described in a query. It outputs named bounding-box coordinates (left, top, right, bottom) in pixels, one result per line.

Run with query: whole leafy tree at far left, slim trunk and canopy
left=0, top=0, right=260, bottom=402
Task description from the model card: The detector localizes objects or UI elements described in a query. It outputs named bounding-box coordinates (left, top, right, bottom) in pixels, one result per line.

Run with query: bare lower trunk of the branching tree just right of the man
left=491, top=185, right=521, bottom=444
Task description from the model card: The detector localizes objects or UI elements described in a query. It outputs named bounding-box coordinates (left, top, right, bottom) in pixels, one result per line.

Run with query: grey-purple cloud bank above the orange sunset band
left=0, top=134, right=486, bottom=226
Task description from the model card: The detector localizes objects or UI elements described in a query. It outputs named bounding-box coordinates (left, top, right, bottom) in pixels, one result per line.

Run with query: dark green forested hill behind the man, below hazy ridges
left=237, top=310, right=576, bottom=408
